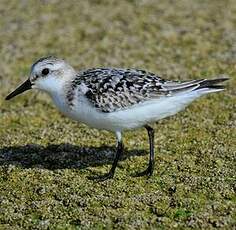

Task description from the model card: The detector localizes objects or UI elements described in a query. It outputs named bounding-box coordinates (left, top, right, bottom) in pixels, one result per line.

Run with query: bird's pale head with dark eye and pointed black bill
left=6, top=56, right=75, bottom=100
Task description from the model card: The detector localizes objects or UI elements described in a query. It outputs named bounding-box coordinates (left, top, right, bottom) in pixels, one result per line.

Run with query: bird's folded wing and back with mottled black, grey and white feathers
left=75, top=68, right=203, bottom=112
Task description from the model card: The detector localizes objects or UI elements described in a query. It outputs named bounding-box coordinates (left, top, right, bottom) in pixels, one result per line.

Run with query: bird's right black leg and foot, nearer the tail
left=135, top=125, right=154, bottom=176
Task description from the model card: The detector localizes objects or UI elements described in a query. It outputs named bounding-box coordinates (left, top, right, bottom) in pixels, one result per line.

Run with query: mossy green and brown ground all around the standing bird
left=0, top=0, right=236, bottom=229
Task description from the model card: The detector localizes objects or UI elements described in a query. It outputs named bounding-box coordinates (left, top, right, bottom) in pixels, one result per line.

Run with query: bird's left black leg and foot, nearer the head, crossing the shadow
left=89, top=140, right=124, bottom=181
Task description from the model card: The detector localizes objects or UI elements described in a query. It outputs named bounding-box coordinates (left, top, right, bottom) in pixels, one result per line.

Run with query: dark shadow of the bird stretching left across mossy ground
left=0, top=144, right=147, bottom=170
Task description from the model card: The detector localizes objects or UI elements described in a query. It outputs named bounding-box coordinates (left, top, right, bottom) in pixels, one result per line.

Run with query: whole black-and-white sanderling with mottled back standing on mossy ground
left=6, top=56, right=228, bottom=180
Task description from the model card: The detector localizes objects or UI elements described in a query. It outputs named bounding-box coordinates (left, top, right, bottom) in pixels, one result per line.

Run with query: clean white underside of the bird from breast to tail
left=52, top=89, right=221, bottom=132
